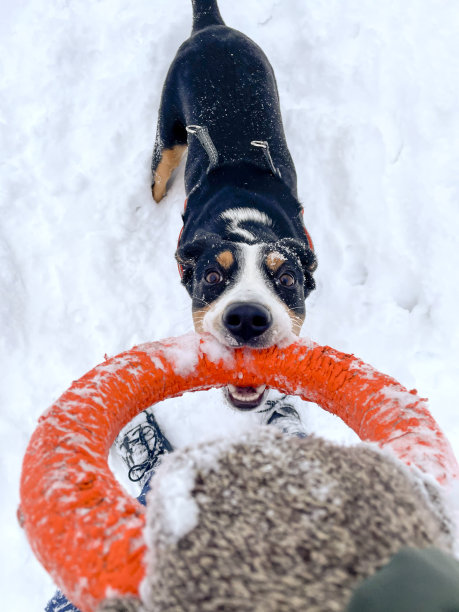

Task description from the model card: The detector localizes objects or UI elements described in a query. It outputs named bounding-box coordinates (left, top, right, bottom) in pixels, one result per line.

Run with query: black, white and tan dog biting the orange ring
left=152, top=0, right=317, bottom=410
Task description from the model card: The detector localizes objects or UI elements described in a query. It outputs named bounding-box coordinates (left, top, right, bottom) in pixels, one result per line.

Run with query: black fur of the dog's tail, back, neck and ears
left=152, top=0, right=317, bottom=326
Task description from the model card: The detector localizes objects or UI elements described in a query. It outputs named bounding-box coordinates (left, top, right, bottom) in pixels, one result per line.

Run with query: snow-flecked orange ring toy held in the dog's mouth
left=18, top=334, right=459, bottom=612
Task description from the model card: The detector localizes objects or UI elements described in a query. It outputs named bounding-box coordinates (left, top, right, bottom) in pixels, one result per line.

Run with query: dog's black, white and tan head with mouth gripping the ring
left=176, top=220, right=316, bottom=410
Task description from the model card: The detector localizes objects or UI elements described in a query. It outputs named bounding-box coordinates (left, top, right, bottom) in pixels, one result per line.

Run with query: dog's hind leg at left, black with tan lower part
left=151, top=70, right=187, bottom=202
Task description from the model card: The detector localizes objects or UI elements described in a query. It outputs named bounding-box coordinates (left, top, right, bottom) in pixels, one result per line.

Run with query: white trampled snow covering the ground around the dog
left=0, top=0, right=459, bottom=612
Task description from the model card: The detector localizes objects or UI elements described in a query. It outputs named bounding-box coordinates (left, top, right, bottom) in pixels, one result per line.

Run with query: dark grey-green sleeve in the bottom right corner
left=346, top=548, right=459, bottom=612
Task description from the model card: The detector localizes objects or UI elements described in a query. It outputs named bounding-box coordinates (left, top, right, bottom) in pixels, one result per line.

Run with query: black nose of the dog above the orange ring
left=223, top=302, right=272, bottom=342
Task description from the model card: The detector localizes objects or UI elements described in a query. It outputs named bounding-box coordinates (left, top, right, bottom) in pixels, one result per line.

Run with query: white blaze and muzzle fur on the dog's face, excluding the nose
left=202, top=244, right=293, bottom=347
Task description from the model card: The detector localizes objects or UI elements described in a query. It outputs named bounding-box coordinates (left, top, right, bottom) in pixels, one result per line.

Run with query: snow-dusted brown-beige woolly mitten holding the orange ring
left=100, top=428, right=452, bottom=612
